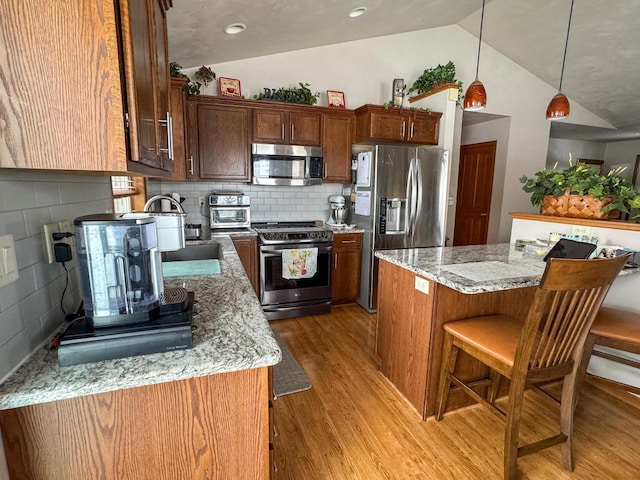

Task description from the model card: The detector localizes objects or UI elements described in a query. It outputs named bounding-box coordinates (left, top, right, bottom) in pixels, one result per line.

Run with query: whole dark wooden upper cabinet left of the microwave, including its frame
left=187, top=95, right=251, bottom=182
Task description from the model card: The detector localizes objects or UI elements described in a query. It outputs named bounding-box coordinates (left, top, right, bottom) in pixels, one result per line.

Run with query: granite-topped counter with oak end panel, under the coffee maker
left=0, top=238, right=281, bottom=480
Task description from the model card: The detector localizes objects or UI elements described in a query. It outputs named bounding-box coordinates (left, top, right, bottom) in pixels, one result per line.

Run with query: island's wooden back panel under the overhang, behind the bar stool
left=424, top=284, right=536, bottom=419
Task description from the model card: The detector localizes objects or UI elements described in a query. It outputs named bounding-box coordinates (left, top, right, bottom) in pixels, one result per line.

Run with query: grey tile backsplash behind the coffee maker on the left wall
left=0, top=170, right=113, bottom=382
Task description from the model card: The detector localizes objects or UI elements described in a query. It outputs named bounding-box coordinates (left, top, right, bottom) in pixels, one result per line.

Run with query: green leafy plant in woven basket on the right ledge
left=520, top=155, right=640, bottom=220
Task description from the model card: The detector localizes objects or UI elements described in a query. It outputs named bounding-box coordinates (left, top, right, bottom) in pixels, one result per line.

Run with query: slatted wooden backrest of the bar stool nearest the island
left=514, top=255, right=628, bottom=378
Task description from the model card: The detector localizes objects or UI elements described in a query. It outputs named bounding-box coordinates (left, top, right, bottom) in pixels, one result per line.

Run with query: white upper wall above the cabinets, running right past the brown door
left=185, top=25, right=611, bottom=244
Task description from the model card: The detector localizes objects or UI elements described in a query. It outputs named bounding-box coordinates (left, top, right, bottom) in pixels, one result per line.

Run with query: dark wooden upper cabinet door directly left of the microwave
left=196, top=104, right=251, bottom=182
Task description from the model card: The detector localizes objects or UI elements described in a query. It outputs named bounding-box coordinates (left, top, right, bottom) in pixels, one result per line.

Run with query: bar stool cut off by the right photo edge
left=580, top=307, right=640, bottom=395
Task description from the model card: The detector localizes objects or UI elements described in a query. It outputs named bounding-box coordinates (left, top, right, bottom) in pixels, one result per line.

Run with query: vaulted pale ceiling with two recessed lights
left=167, top=0, right=640, bottom=141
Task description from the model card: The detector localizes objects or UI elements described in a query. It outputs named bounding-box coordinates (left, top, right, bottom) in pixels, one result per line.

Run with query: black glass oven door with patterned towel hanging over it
left=260, top=243, right=333, bottom=306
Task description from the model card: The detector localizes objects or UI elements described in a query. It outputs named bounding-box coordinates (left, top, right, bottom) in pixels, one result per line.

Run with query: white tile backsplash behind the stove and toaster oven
left=147, top=181, right=343, bottom=226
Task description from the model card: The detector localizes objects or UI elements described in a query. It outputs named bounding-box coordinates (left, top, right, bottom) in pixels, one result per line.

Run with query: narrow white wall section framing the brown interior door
left=462, top=117, right=512, bottom=243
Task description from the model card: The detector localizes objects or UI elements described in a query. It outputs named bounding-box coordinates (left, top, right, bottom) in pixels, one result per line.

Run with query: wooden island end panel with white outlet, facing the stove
left=376, top=260, right=434, bottom=415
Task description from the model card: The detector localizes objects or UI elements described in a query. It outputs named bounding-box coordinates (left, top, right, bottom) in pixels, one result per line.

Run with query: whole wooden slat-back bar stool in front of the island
left=436, top=256, right=627, bottom=479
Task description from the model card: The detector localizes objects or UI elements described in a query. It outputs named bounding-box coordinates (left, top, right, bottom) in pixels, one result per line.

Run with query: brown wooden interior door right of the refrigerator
left=453, top=141, right=497, bottom=245
